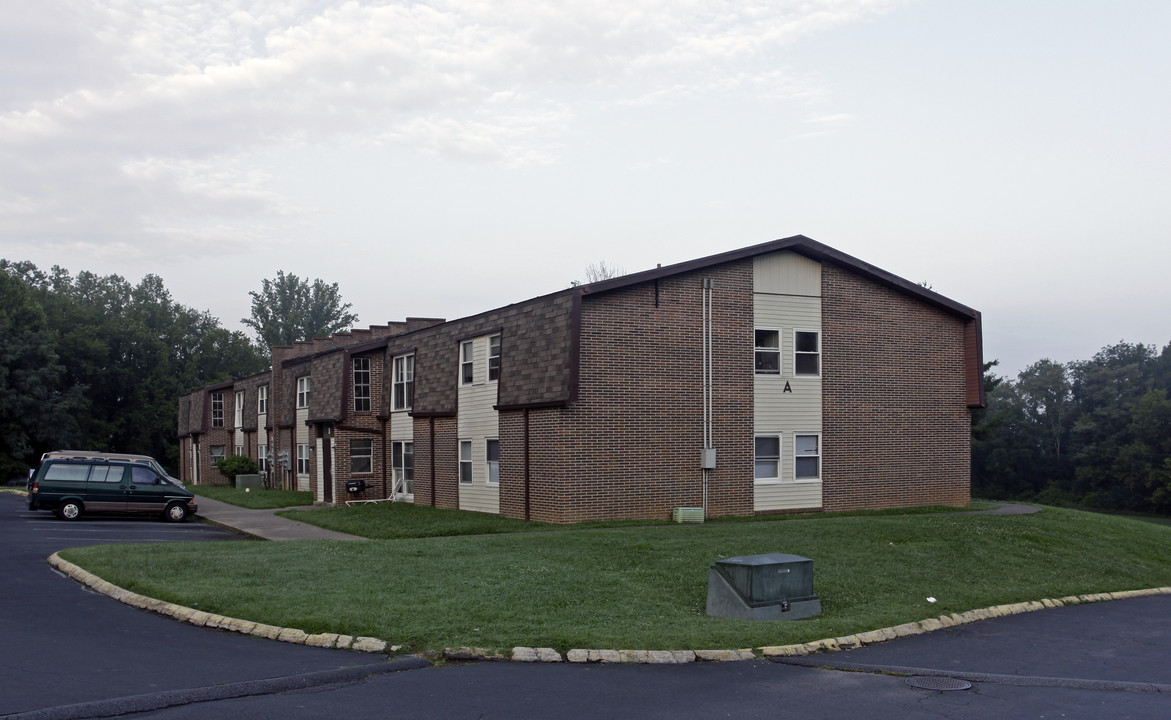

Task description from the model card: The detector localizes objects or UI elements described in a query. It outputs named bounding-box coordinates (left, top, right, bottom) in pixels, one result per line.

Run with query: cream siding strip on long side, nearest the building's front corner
left=456, top=335, right=500, bottom=514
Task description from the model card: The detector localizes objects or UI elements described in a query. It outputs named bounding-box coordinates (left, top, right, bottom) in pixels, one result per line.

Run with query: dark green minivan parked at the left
left=28, top=458, right=198, bottom=522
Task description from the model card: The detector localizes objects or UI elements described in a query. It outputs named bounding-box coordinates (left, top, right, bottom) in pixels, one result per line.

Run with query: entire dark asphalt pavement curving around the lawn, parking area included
left=0, top=495, right=1171, bottom=720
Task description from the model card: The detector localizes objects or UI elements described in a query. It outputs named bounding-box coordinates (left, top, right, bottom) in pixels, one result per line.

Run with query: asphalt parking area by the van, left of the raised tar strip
left=0, top=493, right=385, bottom=715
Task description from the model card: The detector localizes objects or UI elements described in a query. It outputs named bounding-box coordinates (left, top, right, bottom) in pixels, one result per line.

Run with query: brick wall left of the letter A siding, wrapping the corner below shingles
left=500, top=261, right=753, bottom=522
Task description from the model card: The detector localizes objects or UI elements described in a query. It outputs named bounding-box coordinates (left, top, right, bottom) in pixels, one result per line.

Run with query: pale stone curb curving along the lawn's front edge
left=48, top=553, right=1171, bottom=665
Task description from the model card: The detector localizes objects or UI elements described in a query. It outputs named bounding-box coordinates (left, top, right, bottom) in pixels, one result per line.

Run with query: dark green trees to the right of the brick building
left=972, top=342, right=1171, bottom=515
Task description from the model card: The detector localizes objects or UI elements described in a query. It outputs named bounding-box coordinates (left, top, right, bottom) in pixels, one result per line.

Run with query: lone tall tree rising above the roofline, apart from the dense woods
left=240, top=270, right=358, bottom=350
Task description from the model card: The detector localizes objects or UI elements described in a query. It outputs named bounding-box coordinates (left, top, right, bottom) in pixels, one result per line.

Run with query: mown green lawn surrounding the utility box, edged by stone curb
left=62, top=508, right=1171, bottom=651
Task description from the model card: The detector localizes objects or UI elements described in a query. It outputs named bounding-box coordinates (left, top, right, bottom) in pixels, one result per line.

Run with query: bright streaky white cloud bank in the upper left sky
left=0, top=0, right=900, bottom=252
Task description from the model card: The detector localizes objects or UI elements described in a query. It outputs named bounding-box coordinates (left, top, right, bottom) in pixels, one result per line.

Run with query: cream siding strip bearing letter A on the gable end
left=746, top=252, right=824, bottom=510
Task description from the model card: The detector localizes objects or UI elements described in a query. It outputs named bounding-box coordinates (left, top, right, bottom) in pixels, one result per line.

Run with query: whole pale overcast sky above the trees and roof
left=0, top=0, right=1171, bottom=375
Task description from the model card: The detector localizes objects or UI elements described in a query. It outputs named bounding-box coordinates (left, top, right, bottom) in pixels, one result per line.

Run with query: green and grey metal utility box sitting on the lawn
left=707, top=553, right=821, bottom=620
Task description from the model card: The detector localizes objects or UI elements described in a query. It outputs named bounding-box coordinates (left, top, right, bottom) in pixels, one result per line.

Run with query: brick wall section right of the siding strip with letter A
left=822, top=263, right=971, bottom=510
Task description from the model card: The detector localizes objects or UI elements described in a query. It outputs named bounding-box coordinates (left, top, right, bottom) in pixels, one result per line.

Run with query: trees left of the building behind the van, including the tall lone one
left=0, top=260, right=357, bottom=482
